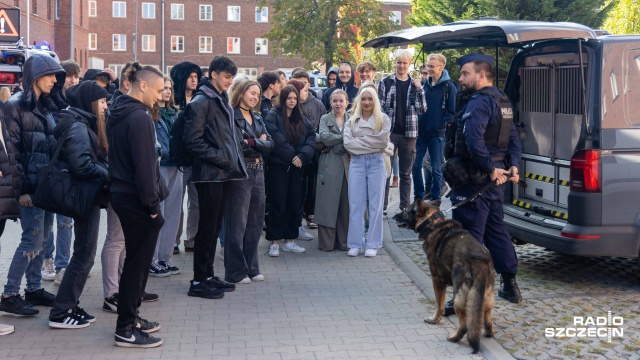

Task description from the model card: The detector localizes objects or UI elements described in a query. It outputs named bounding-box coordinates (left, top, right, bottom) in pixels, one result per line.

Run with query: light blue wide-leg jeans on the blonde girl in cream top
left=347, top=153, right=387, bottom=249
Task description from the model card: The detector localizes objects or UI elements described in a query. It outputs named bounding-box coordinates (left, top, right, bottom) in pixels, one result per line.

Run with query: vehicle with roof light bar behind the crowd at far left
left=0, top=41, right=60, bottom=88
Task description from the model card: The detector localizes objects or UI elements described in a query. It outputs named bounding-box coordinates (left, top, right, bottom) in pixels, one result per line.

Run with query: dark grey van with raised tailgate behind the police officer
left=365, top=19, right=640, bottom=257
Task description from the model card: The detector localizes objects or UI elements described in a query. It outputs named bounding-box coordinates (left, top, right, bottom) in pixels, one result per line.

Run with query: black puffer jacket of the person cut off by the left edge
left=0, top=112, right=22, bottom=220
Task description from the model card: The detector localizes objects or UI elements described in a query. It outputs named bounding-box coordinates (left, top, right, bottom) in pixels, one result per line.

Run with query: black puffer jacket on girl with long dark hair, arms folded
left=265, top=107, right=316, bottom=166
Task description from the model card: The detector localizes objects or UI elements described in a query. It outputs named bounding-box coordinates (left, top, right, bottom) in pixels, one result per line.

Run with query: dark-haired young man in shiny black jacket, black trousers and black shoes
left=183, top=56, right=248, bottom=299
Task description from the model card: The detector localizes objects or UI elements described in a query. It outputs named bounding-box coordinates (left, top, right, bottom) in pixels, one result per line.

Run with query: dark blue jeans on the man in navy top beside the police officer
left=412, top=136, right=444, bottom=200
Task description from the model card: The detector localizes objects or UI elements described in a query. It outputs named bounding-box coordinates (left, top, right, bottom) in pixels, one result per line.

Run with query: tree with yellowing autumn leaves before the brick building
left=258, top=0, right=398, bottom=69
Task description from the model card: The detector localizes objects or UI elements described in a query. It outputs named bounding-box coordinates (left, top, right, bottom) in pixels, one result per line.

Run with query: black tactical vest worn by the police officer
left=454, top=89, right=513, bottom=161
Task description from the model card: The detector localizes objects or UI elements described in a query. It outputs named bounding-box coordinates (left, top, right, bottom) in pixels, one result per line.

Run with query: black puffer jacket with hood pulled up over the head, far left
left=2, top=55, right=66, bottom=195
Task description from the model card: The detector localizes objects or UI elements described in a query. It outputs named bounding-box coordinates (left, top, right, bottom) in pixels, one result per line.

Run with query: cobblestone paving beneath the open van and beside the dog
left=389, top=194, right=640, bottom=359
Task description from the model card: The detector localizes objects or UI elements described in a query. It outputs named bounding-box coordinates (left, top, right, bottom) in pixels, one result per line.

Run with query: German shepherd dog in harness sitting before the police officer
left=393, top=199, right=494, bottom=354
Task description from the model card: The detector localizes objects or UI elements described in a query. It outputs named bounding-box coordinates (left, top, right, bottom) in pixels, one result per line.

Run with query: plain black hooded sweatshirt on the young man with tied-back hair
left=107, top=95, right=167, bottom=215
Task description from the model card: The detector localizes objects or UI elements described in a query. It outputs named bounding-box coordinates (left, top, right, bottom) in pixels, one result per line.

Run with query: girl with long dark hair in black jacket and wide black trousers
left=265, top=85, right=316, bottom=256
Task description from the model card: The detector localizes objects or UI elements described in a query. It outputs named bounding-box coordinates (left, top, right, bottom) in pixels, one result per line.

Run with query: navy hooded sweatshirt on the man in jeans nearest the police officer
left=418, top=70, right=458, bottom=136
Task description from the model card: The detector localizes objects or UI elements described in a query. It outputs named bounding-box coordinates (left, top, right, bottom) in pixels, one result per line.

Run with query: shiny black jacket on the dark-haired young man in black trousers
left=183, top=80, right=248, bottom=182
